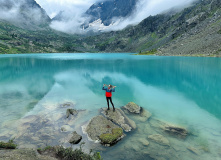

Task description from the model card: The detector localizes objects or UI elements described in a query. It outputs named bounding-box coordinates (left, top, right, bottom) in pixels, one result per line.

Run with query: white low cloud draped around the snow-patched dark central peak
left=48, top=0, right=195, bottom=34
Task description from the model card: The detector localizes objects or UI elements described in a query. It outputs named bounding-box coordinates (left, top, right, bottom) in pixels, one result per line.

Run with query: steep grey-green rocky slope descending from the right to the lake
left=81, top=0, right=221, bottom=56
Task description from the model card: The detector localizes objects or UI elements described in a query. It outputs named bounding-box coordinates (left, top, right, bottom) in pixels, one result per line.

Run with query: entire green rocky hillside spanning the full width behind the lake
left=0, top=0, right=221, bottom=56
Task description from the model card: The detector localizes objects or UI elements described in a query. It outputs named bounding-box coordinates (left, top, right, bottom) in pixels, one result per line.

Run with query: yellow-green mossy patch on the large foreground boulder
left=99, top=128, right=123, bottom=146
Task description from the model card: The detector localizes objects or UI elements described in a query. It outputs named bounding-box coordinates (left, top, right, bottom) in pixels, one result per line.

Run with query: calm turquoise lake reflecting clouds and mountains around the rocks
left=0, top=53, right=221, bottom=160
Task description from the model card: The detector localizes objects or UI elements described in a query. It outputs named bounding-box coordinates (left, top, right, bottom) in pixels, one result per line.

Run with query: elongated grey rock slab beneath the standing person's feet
left=101, top=108, right=136, bottom=132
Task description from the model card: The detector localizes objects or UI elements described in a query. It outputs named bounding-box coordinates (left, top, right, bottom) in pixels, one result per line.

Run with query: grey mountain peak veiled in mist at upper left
left=0, top=0, right=51, bottom=29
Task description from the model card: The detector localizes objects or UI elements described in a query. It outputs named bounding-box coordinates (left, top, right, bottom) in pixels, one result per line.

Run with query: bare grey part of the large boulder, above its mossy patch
left=83, top=115, right=119, bottom=141
